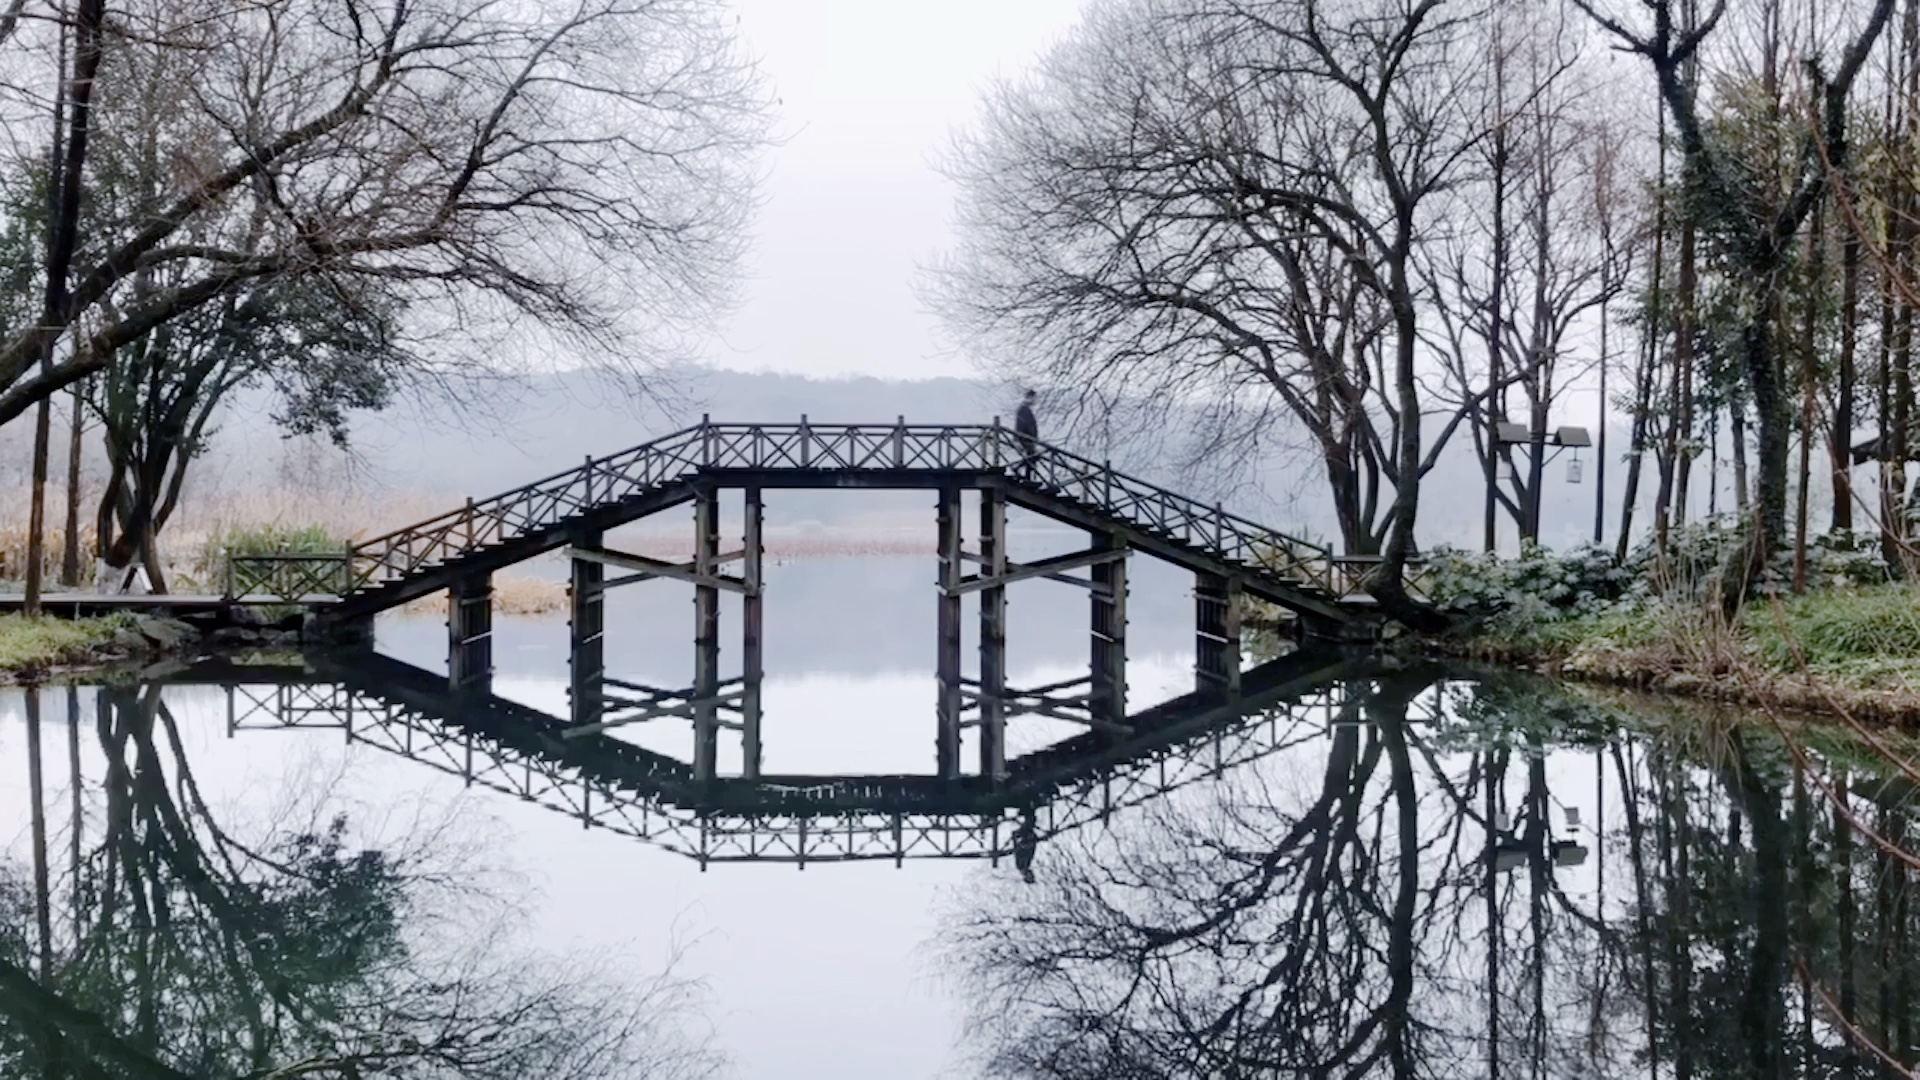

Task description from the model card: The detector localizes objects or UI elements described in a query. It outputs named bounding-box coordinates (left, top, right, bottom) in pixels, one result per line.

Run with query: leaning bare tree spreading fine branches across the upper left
left=0, top=0, right=762, bottom=423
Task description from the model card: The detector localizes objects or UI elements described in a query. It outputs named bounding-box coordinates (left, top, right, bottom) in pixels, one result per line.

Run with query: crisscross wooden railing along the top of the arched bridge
left=322, top=417, right=1338, bottom=592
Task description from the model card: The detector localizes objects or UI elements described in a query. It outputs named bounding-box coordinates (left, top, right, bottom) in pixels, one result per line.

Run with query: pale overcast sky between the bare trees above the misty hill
left=708, top=0, right=1081, bottom=379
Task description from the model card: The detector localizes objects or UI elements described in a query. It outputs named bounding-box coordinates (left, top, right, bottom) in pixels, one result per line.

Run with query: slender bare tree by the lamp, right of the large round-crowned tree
left=1421, top=6, right=1640, bottom=550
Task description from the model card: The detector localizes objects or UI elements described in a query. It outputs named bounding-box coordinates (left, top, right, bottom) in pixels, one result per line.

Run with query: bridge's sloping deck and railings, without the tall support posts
left=247, top=419, right=1405, bottom=614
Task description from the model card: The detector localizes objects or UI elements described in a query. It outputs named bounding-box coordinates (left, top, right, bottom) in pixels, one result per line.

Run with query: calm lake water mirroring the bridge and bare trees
left=0, top=552, right=1920, bottom=1078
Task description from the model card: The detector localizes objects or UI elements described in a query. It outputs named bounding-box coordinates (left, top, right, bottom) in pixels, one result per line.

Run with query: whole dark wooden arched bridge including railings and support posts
left=214, top=417, right=1413, bottom=778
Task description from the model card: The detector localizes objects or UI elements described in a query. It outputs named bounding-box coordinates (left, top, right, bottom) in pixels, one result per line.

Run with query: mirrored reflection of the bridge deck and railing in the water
left=186, top=653, right=1443, bottom=869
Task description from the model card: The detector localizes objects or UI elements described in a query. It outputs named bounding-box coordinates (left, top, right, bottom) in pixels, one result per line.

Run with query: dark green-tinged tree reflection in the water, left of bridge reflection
left=0, top=688, right=720, bottom=1080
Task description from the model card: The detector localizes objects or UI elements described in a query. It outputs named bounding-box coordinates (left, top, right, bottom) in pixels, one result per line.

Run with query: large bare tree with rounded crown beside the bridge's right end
left=943, top=0, right=1484, bottom=611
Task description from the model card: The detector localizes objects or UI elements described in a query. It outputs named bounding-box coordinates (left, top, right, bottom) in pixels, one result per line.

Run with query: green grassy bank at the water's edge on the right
left=1428, top=582, right=1920, bottom=726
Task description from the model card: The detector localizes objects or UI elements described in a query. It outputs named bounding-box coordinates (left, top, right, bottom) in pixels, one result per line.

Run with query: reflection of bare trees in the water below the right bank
left=943, top=671, right=1920, bottom=1078
